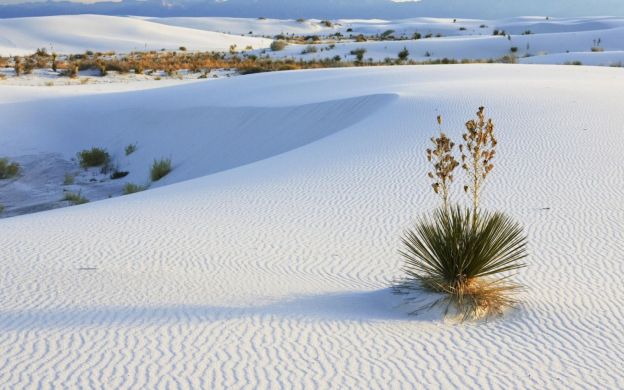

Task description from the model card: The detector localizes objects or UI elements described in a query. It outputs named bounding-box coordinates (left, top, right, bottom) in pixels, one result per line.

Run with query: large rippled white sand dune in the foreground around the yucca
left=0, top=65, right=624, bottom=389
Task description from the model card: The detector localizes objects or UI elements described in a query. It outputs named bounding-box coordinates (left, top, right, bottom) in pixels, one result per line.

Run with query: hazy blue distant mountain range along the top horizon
left=0, top=0, right=624, bottom=19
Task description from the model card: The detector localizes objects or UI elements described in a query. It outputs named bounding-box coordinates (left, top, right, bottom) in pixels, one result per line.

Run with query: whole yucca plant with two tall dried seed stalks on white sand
left=394, top=107, right=527, bottom=321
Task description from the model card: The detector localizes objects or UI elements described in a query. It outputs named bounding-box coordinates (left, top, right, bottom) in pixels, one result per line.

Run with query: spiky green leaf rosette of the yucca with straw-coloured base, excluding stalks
left=395, top=206, right=527, bottom=321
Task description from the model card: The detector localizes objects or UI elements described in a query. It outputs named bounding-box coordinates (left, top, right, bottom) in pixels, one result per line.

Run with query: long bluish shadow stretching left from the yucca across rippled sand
left=0, top=289, right=442, bottom=331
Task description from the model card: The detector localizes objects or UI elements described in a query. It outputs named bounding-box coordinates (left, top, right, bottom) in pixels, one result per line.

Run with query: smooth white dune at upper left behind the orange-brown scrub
left=0, top=15, right=271, bottom=55
